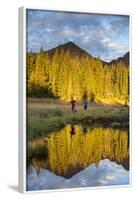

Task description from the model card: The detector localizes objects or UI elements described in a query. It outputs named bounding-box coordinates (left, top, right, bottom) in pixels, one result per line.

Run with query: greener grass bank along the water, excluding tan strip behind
left=27, top=105, right=129, bottom=139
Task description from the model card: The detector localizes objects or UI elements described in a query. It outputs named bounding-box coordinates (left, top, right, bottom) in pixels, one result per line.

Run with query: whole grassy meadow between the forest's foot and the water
left=27, top=98, right=129, bottom=139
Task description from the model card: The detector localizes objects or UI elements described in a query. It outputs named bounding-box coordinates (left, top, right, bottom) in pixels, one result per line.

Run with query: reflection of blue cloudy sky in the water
left=27, top=159, right=129, bottom=190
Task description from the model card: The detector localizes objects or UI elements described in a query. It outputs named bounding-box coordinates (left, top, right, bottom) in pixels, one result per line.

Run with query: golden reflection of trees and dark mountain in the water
left=28, top=125, right=129, bottom=179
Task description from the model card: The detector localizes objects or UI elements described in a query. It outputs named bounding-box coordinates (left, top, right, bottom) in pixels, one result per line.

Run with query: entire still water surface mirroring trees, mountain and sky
left=27, top=125, right=129, bottom=190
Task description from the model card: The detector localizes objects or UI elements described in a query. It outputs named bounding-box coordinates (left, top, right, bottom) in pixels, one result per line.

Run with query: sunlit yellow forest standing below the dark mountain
left=27, top=44, right=129, bottom=104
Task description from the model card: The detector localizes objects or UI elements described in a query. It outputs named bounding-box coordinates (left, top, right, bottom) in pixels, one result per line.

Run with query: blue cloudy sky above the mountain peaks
left=26, top=10, right=129, bottom=61
